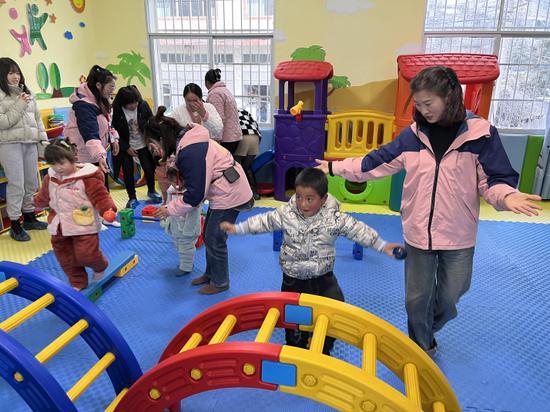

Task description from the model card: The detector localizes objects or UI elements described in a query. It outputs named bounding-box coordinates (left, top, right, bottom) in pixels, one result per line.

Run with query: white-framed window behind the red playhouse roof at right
left=424, top=0, right=550, bottom=130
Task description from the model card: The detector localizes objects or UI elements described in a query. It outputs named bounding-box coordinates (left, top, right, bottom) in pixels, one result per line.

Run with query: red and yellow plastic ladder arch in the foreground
left=114, top=292, right=460, bottom=412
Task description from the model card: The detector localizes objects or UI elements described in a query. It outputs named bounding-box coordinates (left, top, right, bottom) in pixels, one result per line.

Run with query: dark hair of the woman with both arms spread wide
left=407, top=66, right=466, bottom=126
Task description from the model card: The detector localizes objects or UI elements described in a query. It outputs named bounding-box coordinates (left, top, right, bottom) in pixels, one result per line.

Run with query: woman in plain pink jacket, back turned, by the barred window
left=204, top=69, right=243, bottom=154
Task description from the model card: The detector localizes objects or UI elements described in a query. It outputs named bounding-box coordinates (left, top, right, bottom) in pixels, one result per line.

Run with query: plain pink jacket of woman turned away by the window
left=206, top=82, right=243, bottom=143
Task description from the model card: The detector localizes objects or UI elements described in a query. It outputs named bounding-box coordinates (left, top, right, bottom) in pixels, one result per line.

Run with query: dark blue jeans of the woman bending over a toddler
left=204, top=208, right=239, bottom=287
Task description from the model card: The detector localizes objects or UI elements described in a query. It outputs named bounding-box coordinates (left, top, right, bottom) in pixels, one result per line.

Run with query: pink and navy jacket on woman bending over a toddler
left=167, top=125, right=252, bottom=216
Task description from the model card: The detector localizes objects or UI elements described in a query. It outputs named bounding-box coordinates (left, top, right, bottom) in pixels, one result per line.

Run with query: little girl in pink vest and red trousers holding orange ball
left=34, top=140, right=116, bottom=290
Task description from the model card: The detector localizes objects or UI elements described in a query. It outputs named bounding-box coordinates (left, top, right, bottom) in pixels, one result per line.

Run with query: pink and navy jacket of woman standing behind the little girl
left=64, top=83, right=118, bottom=163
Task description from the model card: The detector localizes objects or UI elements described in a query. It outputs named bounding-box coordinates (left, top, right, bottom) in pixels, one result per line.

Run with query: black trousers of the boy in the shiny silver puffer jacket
left=281, top=272, right=344, bottom=355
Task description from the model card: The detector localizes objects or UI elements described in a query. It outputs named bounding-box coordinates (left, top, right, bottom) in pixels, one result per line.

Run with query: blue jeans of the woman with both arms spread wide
left=405, top=244, right=474, bottom=350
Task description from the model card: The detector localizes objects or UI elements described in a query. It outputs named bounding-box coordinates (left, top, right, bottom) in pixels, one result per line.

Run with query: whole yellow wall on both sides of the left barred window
left=0, top=0, right=426, bottom=112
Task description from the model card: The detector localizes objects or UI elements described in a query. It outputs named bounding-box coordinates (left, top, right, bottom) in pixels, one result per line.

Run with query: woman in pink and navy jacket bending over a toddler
left=151, top=106, right=254, bottom=295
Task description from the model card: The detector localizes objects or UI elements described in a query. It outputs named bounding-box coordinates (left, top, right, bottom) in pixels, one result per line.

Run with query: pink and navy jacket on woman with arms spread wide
left=332, top=116, right=518, bottom=250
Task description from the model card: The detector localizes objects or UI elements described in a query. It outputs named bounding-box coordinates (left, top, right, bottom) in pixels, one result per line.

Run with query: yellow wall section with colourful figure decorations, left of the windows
left=0, top=0, right=152, bottom=108
